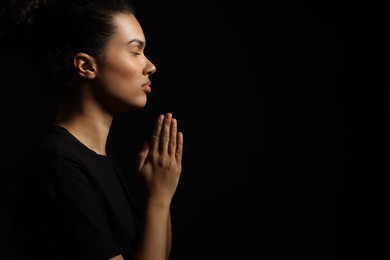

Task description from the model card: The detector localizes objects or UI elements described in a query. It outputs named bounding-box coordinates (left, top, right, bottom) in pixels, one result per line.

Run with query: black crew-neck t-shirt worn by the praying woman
left=15, top=125, right=139, bottom=260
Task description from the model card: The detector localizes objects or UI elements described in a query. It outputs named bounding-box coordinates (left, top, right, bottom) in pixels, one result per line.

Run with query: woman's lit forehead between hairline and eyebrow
left=112, top=13, right=145, bottom=42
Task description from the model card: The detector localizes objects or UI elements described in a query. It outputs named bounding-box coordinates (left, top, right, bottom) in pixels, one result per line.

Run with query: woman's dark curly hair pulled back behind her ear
left=0, top=0, right=135, bottom=100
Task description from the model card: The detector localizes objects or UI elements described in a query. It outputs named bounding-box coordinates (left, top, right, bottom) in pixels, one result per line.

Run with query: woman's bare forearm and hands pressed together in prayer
left=112, top=113, right=183, bottom=260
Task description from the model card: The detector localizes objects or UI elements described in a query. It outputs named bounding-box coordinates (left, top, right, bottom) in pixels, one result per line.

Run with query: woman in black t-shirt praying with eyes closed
left=1, top=0, right=183, bottom=260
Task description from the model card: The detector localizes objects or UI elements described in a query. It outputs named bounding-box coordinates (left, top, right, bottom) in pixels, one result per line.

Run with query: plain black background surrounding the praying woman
left=1, top=0, right=389, bottom=260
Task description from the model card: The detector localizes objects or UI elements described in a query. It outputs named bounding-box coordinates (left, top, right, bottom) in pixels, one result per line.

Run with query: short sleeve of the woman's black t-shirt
left=33, top=153, right=121, bottom=260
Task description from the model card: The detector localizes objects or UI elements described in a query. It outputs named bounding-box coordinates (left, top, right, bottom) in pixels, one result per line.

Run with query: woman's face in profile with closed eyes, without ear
left=96, top=14, right=156, bottom=113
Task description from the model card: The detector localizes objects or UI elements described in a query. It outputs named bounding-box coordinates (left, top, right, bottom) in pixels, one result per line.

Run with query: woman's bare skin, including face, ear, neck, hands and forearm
left=55, top=14, right=183, bottom=260
